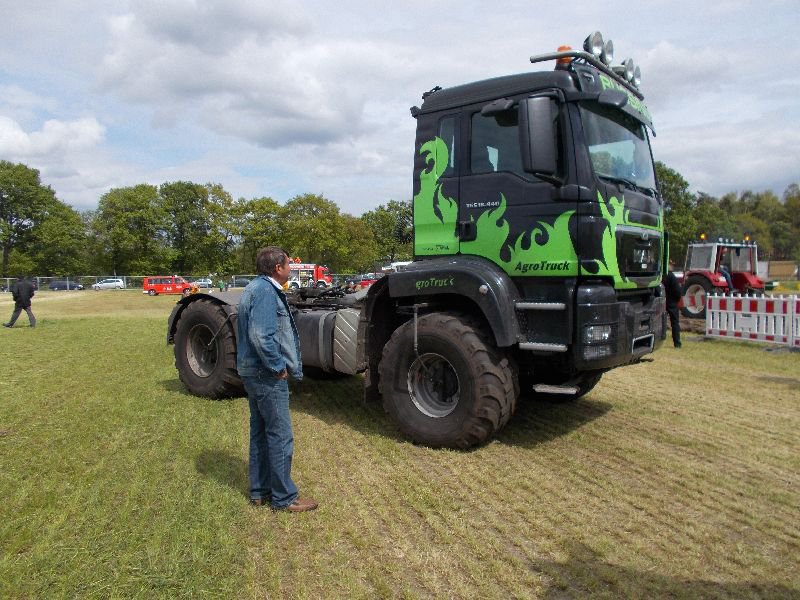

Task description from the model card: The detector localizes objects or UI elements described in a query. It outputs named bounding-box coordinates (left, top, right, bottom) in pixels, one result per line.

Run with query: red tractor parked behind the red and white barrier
left=679, top=239, right=764, bottom=319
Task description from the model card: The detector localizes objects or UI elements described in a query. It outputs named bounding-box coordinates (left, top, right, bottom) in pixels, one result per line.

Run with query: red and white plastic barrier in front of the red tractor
left=706, top=294, right=800, bottom=349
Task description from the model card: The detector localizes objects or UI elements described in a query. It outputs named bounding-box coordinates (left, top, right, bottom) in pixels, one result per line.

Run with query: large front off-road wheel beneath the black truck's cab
left=379, top=313, right=518, bottom=448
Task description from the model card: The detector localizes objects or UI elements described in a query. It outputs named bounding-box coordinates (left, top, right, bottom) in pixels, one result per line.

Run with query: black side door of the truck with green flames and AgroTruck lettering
left=457, top=98, right=577, bottom=276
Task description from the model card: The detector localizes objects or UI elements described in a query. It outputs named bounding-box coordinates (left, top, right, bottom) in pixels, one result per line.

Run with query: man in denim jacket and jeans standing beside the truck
left=236, top=246, right=317, bottom=512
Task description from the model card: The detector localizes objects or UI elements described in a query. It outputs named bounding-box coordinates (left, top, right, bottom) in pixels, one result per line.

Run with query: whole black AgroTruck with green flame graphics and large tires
left=167, top=32, right=666, bottom=448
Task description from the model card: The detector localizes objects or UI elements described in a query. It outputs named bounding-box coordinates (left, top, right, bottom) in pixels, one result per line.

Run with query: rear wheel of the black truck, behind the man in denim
left=175, top=300, right=243, bottom=399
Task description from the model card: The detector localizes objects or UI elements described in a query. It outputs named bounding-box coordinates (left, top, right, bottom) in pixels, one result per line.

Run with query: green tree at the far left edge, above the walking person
left=0, top=160, right=55, bottom=277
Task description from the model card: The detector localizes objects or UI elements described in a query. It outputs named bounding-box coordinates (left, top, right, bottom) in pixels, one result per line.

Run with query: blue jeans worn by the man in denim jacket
left=242, top=373, right=297, bottom=508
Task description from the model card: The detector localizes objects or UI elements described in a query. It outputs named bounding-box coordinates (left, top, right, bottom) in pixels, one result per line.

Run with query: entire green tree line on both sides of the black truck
left=0, top=161, right=800, bottom=277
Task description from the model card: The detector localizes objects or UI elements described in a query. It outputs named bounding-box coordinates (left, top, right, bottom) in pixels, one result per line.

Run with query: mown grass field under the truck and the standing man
left=0, top=291, right=800, bottom=599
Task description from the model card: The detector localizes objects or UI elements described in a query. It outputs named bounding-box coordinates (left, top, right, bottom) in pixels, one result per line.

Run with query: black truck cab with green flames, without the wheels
left=404, top=31, right=665, bottom=379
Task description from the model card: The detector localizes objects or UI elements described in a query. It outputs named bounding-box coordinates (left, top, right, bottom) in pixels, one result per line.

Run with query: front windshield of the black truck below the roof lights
left=580, top=102, right=656, bottom=193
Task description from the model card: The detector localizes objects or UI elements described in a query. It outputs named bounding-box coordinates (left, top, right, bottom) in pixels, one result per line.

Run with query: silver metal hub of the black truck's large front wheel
left=408, top=352, right=461, bottom=419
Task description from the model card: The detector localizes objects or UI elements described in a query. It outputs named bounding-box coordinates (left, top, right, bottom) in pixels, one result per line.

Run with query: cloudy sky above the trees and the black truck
left=0, top=0, right=800, bottom=215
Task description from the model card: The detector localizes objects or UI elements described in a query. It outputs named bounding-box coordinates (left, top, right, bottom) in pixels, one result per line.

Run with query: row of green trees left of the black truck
left=0, top=161, right=411, bottom=277
